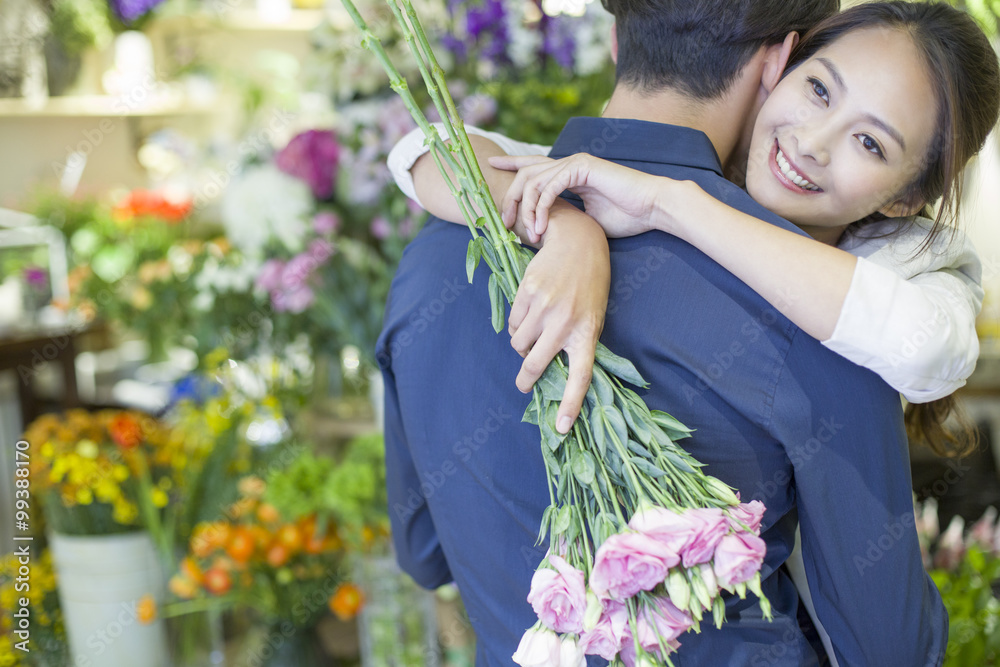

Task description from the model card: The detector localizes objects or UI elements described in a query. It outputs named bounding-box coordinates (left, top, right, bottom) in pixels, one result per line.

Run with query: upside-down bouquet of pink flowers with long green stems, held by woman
left=343, top=0, right=770, bottom=667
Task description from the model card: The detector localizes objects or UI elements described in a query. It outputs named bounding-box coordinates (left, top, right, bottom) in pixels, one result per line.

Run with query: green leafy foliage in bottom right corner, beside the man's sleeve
left=930, top=545, right=1000, bottom=667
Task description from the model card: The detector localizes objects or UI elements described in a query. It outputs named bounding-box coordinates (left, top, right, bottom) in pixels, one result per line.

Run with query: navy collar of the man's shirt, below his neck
left=549, top=118, right=722, bottom=176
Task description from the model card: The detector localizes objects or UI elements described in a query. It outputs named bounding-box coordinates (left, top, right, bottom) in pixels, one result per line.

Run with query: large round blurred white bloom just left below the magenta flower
left=222, top=164, right=313, bottom=255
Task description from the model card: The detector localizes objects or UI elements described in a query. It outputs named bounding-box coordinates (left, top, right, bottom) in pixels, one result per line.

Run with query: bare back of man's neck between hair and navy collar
left=602, top=85, right=742, bottom=172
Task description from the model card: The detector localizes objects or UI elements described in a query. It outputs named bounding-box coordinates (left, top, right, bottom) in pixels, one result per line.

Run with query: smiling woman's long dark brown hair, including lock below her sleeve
left=788, top=1, right=1000, bottom=456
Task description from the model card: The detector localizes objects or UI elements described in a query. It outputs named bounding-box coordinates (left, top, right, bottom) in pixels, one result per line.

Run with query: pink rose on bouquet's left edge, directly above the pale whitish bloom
left=528, top=553, right=587, bottom=634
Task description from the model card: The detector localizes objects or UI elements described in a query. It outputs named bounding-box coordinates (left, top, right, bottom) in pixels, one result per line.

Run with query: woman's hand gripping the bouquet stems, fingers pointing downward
left=509, top=200, right=611, bottom=433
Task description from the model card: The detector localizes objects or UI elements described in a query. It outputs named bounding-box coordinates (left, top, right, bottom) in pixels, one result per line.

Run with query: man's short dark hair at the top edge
left=602, top=0, right=840, bottom=100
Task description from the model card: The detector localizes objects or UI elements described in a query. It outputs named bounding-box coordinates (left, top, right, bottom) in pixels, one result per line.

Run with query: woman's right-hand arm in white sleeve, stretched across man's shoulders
left=491, top=156, right=982, bottom=403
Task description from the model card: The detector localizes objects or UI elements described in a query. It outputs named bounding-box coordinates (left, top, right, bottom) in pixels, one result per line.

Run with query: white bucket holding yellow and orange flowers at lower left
left=49, top=532, right=169, bottom=667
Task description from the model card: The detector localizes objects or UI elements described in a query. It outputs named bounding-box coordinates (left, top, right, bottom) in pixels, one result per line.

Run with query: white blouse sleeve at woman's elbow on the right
left=823, top=222, right=983, bottom=403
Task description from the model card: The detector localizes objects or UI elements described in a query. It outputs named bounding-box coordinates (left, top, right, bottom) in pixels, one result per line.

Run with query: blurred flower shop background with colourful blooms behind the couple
left=0, top=0, right=1000, bottom=667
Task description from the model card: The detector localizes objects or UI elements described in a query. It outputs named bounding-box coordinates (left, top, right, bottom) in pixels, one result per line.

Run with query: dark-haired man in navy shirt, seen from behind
left=377, top=0, right=947, bottom=667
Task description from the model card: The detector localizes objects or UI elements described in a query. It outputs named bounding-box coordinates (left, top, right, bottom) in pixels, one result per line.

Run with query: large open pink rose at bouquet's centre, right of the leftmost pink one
left=590, top=533, right=680, bottom=600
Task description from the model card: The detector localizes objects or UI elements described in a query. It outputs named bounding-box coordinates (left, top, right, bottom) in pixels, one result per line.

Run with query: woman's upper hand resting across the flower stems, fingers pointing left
left=489, top=153, right=678, bottom=238
